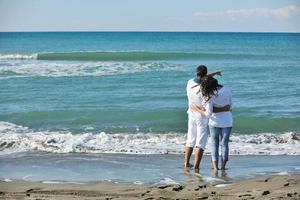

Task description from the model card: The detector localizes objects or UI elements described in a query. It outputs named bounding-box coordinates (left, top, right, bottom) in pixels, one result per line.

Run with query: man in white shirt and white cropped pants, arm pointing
left=184, top=65, right=229, bottom=173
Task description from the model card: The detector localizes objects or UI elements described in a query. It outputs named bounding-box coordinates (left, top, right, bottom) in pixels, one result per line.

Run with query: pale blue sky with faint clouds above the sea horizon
left=0, top=0, right=300, bottom=32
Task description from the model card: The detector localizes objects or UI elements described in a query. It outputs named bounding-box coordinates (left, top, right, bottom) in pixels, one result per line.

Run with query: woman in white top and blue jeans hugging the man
left=193, top=77, right=232, bottom=171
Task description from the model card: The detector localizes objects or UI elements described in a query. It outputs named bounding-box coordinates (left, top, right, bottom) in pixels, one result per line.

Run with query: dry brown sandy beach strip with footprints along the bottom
left=0, top=175, right=300, bottom=200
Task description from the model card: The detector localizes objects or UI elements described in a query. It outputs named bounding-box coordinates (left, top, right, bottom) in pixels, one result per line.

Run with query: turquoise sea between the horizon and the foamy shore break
left=0, top=32, right=300, bottom=155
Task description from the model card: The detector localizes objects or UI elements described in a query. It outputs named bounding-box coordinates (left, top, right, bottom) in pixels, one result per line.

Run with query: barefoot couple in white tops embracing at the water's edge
left=184, top=65, right=232, bottom=173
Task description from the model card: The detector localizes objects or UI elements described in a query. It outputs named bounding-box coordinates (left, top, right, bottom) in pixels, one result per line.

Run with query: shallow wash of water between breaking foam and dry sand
left=0, top=153, right=300, bottom=184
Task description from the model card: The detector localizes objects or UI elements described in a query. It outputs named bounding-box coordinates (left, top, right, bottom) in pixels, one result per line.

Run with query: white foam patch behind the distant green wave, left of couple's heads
left=0, top=60, right=179, bottom=79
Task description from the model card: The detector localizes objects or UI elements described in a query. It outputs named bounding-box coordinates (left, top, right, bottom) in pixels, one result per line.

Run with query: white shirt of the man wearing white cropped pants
left=186, top=79, right=213, bottom=123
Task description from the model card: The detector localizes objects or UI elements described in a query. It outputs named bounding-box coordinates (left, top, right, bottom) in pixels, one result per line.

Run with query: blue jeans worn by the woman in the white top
left=209, top=126, right=232, bottom=161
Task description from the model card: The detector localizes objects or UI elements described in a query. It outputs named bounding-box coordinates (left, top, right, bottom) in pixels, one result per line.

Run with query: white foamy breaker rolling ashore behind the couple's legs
left=0, top=122, right=300, bottom=155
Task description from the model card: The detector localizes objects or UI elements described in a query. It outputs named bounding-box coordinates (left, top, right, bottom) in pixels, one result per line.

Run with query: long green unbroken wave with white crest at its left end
left=0, top=51, right=266, bottom=61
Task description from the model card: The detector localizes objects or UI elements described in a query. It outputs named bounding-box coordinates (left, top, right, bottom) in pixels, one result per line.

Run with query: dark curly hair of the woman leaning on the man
left=201, top=76, right=221, bottom=101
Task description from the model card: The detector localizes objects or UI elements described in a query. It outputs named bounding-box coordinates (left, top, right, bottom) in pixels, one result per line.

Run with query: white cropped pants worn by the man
left=186, top=117, right=208, bottom=150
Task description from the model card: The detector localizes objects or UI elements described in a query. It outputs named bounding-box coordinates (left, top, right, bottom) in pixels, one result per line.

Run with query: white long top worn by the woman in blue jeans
left=209, top=86, right=233, bottom=128
